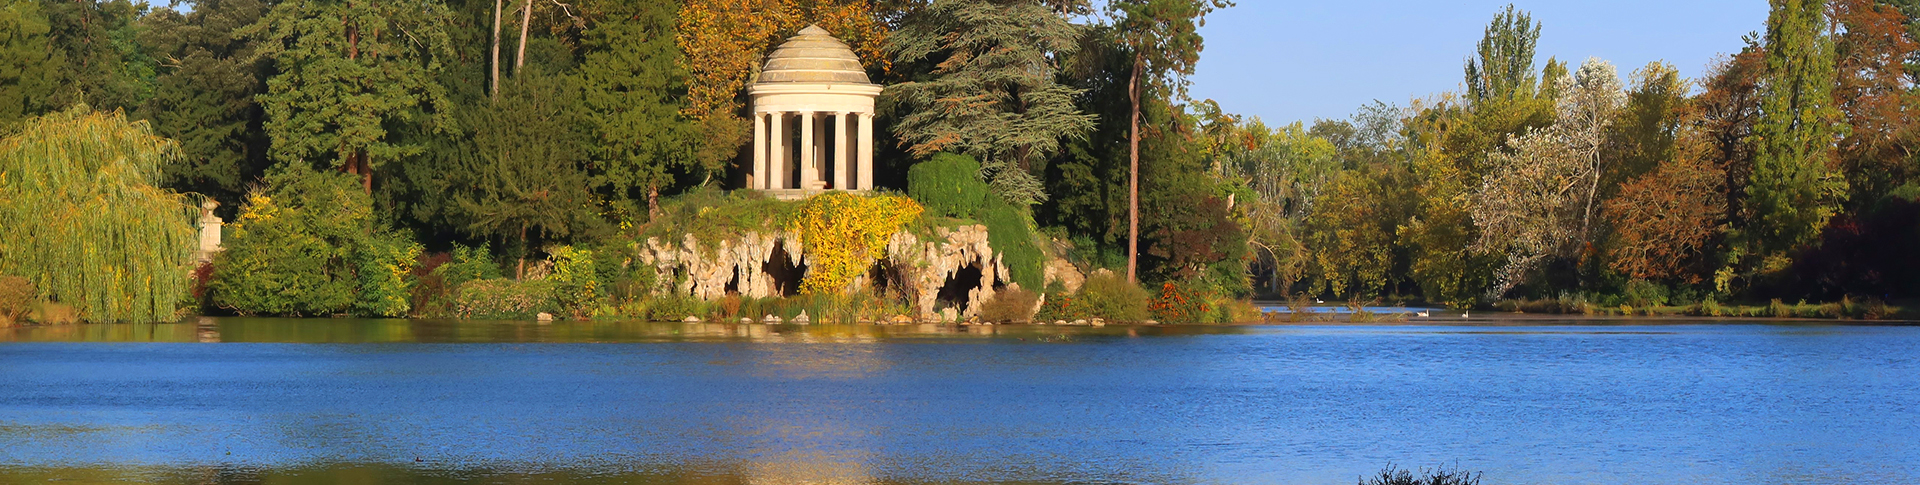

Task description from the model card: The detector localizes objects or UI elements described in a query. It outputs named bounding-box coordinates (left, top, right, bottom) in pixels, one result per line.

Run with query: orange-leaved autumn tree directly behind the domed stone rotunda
left=676, top=0, right=889, bottom=170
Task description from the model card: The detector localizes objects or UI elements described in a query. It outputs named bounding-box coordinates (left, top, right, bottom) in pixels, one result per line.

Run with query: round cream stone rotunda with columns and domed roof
left=747, top=25, right=881, bottom=199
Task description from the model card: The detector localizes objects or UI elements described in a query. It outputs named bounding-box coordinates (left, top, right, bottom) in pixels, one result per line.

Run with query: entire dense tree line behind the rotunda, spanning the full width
left=0, top=0, right=1920, bottom=318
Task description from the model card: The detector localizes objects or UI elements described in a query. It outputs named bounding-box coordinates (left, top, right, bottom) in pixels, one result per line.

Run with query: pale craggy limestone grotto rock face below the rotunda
left=634, top=224, right=1013, bottom=320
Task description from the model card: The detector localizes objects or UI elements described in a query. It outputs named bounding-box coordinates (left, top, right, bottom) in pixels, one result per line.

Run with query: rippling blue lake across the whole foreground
left=0, top=318, right=1920, bottom=485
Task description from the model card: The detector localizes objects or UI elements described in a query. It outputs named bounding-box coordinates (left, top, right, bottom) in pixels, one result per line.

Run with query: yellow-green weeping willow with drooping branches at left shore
left=0, top=105, right=198, bottom=322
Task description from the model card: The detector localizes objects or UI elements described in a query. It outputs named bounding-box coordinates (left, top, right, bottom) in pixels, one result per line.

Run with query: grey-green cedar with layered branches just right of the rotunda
left=887, top=0, right=1094, bottom=205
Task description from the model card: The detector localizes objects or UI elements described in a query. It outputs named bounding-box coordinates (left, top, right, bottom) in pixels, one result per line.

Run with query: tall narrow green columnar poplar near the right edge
left=1716, top=0, right=1847, bottom=279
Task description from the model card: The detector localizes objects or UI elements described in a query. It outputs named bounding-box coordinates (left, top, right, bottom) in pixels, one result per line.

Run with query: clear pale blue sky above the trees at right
left=1190, top=0, right=1766, bottom=125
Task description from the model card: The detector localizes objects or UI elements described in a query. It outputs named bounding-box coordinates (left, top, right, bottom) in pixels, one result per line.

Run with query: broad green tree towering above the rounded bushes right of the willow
left=244, top=0, right=453, bottom=194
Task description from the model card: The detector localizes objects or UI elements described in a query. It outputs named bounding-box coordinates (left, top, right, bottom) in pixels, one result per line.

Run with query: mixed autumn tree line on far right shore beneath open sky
left=1204, top=0, right=1920, bottom=305
